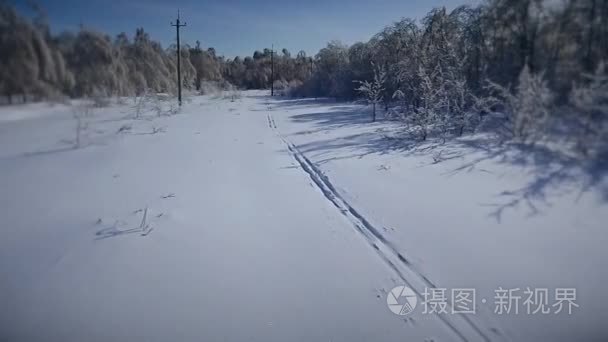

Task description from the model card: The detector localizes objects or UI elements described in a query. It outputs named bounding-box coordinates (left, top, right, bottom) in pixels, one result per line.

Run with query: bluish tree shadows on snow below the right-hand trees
left=275, top=100, right=608, bottom=222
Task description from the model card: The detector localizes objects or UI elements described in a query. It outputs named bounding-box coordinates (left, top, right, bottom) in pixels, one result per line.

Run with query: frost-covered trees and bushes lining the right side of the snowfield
left=291, top=0, right=608, bottom=158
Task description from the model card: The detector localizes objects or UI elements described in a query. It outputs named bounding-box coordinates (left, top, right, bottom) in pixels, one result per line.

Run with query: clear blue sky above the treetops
left=13, top=0, right=479, bottom=57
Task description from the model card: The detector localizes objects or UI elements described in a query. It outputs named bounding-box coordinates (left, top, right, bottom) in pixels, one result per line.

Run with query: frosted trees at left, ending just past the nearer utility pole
left=0, top=3, right=197, bottom=102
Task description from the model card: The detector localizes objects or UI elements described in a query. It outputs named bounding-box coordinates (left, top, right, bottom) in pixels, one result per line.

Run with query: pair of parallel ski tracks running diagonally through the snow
left=267, top=108, right=506, bottom=341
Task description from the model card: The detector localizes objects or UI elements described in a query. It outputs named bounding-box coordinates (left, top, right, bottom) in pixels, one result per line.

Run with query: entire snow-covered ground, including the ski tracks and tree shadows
left=0, top=92, right=608, bottom=341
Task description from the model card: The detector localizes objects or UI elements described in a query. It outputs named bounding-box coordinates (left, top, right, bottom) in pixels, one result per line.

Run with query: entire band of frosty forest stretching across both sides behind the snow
left=0, top=0, right=608, bottom=159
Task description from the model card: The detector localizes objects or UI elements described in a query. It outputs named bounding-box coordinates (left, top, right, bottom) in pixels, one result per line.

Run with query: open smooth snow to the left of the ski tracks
left=0, top=96, right=484, bottom=341
